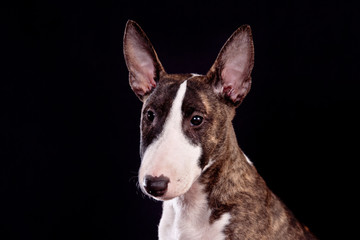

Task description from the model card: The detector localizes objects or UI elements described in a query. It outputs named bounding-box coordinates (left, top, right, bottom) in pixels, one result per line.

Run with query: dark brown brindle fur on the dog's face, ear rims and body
left=124, top=21, right=316, bottom=240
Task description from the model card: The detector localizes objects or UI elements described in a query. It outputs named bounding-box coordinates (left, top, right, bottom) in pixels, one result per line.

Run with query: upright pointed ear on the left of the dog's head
left=123, top=20, right=165, bottom=101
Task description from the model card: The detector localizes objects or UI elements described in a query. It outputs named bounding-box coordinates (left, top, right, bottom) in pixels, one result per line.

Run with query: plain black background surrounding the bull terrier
left=0, top=0, right=359, bottom=239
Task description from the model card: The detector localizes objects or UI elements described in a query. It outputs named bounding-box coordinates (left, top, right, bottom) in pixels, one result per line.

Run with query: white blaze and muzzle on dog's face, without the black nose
left=139, top=81, right=201, bottom=200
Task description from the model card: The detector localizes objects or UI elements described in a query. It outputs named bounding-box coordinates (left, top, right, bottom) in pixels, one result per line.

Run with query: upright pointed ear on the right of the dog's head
left=208, top=25, right=254, bottom=106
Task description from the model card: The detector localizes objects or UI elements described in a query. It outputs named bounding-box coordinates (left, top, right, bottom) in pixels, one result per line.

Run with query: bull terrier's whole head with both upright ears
left=124, top=21, right=254, bottom=200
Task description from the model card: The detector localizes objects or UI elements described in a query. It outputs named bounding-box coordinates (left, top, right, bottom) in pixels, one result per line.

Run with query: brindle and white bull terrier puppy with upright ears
left=123, top=20, right=316, bottom=240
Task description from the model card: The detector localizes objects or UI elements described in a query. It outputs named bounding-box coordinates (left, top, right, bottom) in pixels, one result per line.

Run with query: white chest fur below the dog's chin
left=159, top=183, right=230, bottom=240
